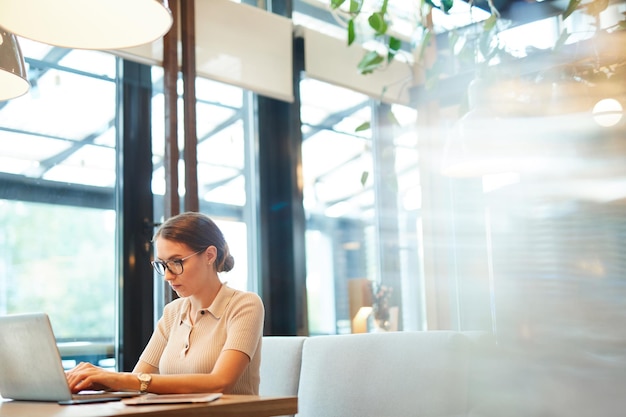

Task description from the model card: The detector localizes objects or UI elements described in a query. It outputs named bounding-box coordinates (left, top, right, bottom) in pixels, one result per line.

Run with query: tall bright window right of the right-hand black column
left=300, top=78, right=423, bottom=334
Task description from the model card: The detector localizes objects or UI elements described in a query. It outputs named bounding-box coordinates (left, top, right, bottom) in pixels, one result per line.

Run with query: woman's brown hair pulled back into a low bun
left=152, top=211, right=235, bottom=272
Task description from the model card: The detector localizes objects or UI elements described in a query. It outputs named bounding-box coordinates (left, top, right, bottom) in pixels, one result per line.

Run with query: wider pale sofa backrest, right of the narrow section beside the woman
left=297, top=331, right=469, bottom=417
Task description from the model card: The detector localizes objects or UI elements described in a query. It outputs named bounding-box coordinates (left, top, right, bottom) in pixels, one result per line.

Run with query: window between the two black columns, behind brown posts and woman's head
left=152, top=67, right=258, bottom=300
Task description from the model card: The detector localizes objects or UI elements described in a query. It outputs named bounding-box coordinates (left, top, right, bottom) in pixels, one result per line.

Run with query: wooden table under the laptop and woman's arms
left=0, top=395, right=298, bottom=417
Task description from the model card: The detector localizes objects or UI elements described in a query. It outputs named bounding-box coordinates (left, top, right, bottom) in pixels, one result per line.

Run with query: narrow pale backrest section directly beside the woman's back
left=259, top=336, right=306, bottom=396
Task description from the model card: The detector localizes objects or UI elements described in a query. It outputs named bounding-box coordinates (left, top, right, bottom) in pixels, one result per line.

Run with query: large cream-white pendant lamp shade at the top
left=0, top=0, right=173, bottom=49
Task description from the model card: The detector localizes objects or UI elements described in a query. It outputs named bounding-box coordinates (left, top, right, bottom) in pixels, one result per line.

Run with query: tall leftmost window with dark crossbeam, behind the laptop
left=0, top=40, right=117, bottom=366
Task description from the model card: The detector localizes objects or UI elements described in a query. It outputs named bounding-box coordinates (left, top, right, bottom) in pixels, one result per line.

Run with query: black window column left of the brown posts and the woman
left=116, top=60, right=154, bottom=371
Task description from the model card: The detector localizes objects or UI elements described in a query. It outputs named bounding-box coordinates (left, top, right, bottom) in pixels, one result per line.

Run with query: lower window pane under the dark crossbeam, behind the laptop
left=0, top=200, right=117, bottom=344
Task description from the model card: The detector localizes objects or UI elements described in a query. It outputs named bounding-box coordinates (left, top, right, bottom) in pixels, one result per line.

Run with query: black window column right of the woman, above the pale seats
left=257, top=35, right=308, bottom=335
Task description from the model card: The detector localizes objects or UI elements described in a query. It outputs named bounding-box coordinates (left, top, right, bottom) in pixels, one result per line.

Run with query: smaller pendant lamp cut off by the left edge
left=0, top=28, right=30, bottom=101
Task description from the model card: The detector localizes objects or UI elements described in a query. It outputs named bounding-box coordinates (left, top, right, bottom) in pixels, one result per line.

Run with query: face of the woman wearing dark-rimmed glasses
left=155, top=238, right=209, bottom=297
